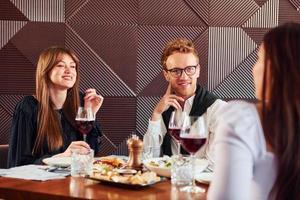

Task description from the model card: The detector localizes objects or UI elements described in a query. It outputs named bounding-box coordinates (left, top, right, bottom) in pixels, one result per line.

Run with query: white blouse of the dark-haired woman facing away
left=208, top=102, right=277, bottom=200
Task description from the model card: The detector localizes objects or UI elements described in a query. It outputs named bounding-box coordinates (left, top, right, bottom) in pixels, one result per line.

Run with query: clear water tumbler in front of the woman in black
left=71, top=149, right=94, bottom=177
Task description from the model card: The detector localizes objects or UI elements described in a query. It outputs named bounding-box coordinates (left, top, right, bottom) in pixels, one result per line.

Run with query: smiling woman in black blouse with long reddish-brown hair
left=8, top=47, right=103, bottom=167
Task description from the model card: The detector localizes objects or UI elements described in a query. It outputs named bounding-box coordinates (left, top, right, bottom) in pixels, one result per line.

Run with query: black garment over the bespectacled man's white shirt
left=161, top=85, right=218, bottom=156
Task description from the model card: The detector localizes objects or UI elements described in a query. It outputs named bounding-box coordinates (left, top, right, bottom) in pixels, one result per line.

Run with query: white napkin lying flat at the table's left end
left=0, top=165, right=69, bottom=181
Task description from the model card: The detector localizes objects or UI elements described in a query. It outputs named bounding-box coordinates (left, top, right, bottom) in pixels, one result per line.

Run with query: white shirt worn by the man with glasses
left=144, top=95, right=226, bottom=164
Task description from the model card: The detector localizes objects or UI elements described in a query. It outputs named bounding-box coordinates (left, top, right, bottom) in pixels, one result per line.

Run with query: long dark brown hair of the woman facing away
left=262, top=23, right=300, bottom=200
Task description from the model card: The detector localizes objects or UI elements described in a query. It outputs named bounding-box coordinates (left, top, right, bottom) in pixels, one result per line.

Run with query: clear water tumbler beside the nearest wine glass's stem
left=171, top=155, right=193, bottom=186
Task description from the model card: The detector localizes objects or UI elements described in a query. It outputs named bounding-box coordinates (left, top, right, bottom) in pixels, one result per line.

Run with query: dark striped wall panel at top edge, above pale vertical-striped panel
left=209, top=0, right=259, bottom=27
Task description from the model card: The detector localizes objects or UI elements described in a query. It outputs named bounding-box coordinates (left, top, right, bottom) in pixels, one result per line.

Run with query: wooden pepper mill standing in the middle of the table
left=127, top=135, right=143, bottom=170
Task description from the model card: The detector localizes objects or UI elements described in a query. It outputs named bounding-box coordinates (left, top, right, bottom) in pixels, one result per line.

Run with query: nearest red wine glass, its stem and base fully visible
left=180, top=116, right=208, bottom=193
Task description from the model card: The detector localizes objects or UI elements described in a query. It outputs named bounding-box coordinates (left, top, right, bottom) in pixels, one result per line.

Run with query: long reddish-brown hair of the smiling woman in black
left=33, top=46, right=80, bottom=153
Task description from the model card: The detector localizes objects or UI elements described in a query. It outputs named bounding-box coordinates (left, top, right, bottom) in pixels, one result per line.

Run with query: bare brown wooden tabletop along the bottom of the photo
left=0, top=177, right=207, bottom=200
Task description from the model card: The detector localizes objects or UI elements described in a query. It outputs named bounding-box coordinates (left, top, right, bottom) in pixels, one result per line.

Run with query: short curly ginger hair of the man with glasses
left=161, top=38, right=199, bottom=69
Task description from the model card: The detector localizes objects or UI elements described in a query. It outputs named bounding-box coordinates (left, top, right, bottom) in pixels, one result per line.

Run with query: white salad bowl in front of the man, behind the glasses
left=143, top=158, right=208, bottom=178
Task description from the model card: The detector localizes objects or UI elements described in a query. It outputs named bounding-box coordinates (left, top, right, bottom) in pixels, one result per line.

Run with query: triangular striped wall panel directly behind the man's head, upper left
left=137, top=26, right=206, bottom=93
